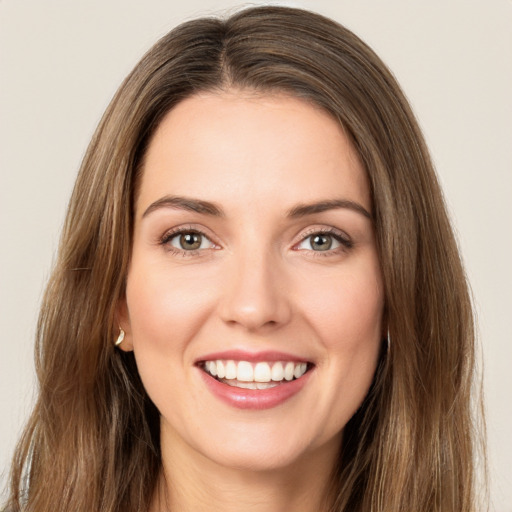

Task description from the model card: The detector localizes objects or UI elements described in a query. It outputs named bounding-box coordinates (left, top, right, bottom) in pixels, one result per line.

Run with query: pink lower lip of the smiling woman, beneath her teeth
left=198, top=368, right=311, bottom=410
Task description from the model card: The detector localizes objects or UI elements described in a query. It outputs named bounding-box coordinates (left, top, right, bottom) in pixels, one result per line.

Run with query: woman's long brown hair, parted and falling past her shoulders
left=5, top=7, right=484, bottom=512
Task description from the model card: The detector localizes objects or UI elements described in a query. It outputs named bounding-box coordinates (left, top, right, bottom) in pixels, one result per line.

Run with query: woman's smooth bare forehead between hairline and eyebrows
left=136, top=91, right=371, bottom=217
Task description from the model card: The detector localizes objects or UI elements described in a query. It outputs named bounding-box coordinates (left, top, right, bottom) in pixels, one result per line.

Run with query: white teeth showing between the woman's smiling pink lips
left=203, top=360, right=308, bottom=389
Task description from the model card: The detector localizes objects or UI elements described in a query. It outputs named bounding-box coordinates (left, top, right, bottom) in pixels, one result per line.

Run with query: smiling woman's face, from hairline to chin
left=119, top=91, right=383, bottom=469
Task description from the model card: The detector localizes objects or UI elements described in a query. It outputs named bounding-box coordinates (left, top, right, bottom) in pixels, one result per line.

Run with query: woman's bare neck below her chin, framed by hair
left=150, top=426, right=339, bottom=512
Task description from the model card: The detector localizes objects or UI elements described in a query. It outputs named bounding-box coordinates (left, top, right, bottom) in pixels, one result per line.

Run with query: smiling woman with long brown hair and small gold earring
left=5, top=7, right=484, bottom=512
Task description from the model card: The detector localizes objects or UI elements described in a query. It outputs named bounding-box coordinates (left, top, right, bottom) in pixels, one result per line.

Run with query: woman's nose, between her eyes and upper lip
left=219, top=250, right=292, bottom=331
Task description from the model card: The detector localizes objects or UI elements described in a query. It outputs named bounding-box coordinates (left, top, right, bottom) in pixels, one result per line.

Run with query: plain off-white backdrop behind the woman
left=0, top=0, right=512, bottom=512
